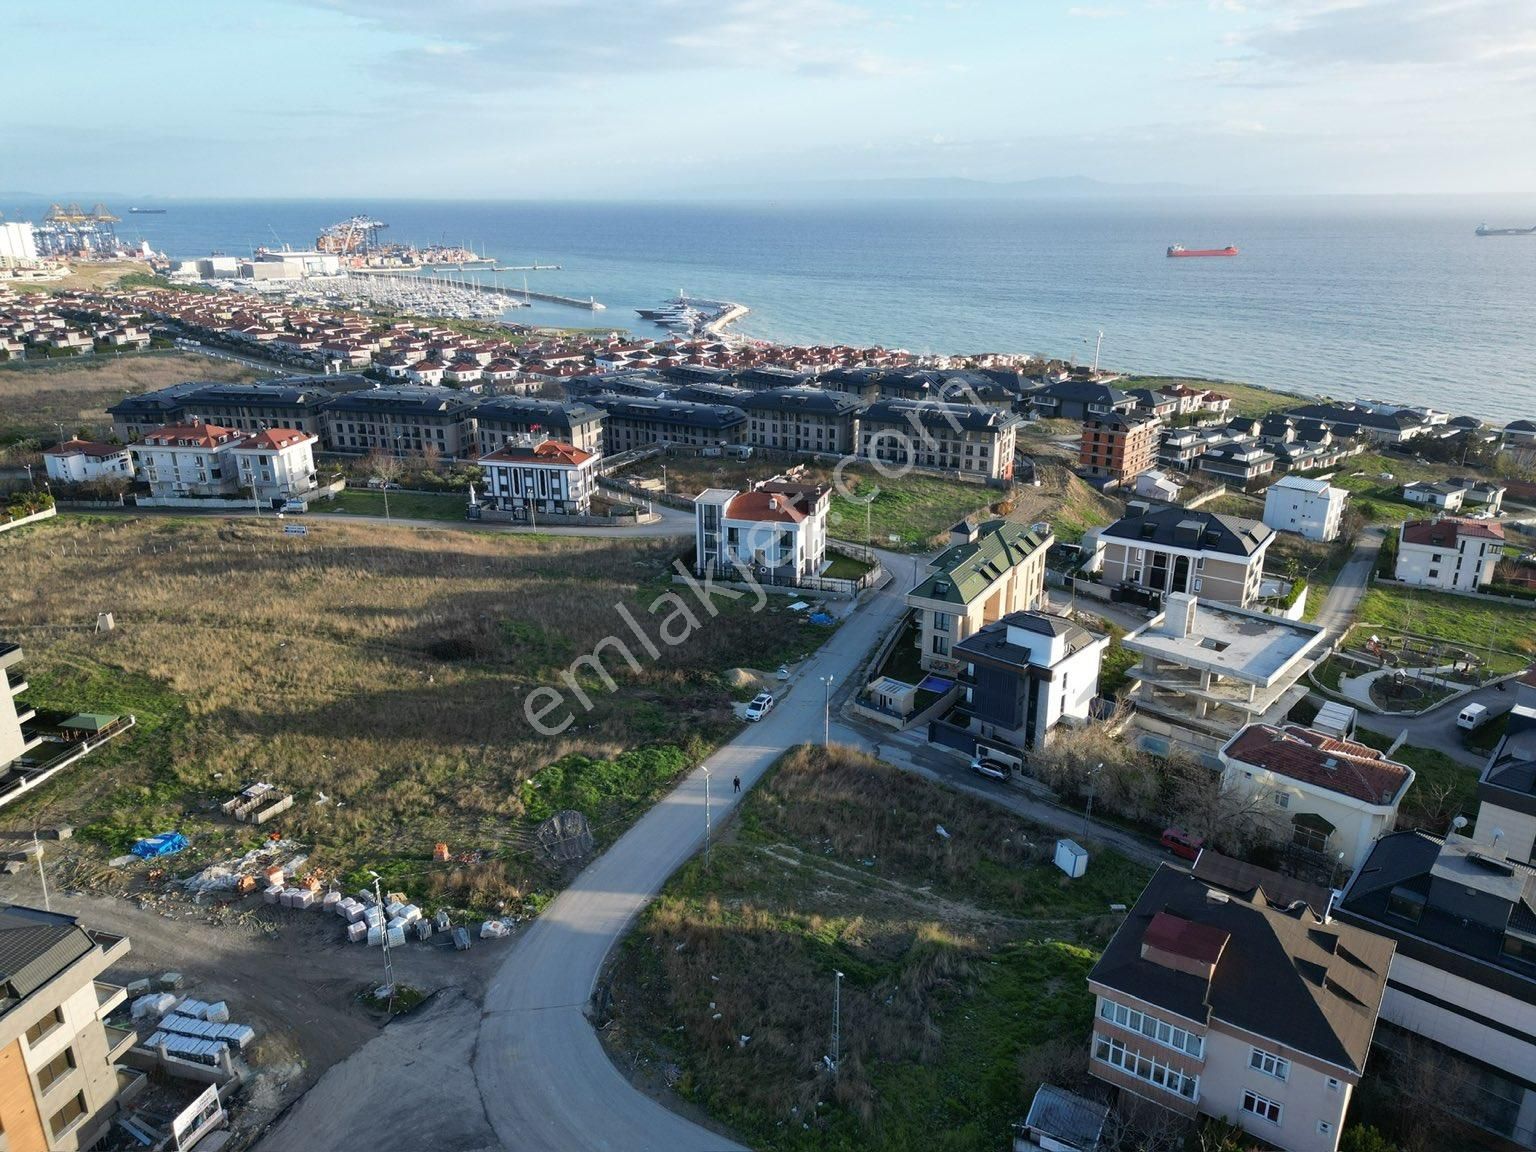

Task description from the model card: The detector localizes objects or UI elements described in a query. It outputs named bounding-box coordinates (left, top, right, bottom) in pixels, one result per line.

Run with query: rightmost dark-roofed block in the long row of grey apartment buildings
left=859, top=399, right=1021, bottom=482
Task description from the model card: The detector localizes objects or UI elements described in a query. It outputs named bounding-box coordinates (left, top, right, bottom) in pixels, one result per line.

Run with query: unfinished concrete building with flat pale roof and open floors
left=1120, top=593, right=1322, bottom=768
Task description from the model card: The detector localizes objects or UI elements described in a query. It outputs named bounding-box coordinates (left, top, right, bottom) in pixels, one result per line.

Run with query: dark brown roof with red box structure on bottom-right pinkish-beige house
left=1089, top=865, right=1393, bottom=1072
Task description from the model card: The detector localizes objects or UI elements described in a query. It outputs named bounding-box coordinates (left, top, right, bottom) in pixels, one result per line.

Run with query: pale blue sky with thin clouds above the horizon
left=9, top=0, right=1536, bottom=200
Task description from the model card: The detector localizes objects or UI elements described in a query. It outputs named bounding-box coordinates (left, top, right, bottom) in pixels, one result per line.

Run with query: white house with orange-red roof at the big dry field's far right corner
left=694, top=479, right=833, bottom=585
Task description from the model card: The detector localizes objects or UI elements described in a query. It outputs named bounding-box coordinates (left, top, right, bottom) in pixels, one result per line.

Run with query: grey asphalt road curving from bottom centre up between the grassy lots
left=475, top=554, right=909, bottom=1152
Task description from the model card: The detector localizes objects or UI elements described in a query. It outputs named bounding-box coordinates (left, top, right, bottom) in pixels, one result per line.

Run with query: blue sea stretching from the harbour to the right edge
left=42, top=198, right=1536, bottom=419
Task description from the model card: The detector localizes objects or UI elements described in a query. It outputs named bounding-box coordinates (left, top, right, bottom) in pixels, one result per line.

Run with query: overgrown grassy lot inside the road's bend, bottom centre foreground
left=607, top=748, right=1146, bottom=1150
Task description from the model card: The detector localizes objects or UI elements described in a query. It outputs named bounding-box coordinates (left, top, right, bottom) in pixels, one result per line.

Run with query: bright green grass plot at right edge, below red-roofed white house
left=1352, top=585, right=1536, bottom=673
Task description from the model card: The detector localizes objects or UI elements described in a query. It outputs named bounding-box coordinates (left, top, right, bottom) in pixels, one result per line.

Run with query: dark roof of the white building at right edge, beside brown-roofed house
left=1336, top=831, right=1536, bottom=1005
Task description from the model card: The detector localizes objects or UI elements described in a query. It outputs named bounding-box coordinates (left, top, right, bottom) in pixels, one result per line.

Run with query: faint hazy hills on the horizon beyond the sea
left=694, top=177, right=1210, bottom=200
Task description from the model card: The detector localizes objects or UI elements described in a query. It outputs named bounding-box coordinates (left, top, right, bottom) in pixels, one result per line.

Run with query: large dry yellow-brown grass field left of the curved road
left=0, top=516, right=825, bottom=902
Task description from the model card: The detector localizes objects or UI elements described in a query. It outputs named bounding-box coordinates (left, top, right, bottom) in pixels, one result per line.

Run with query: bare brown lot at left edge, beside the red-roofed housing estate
left=0, top=352, right=270, bottom=442
